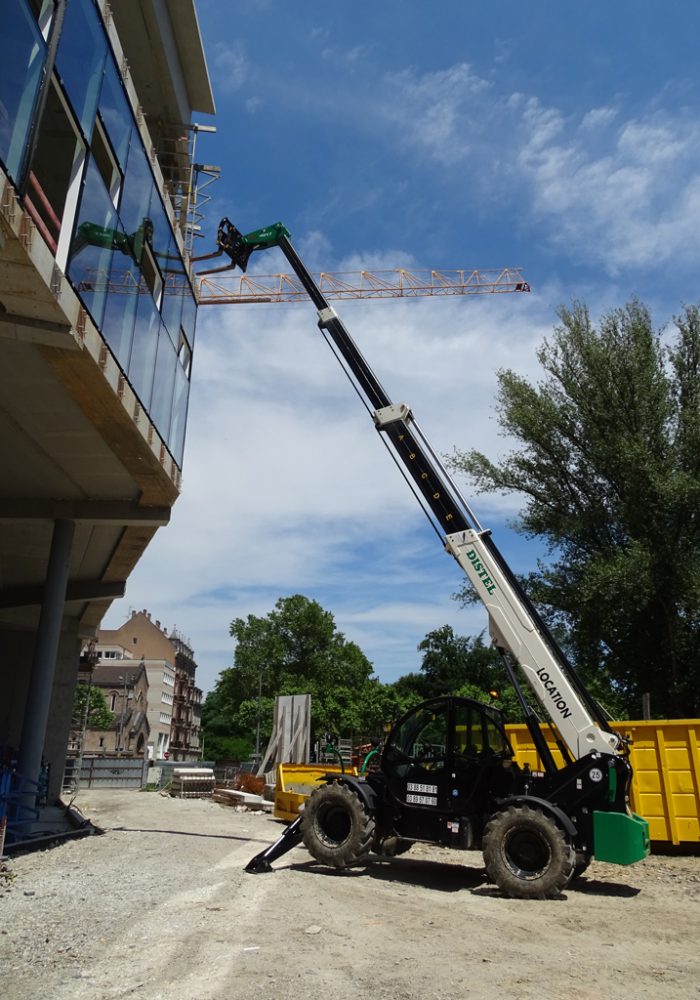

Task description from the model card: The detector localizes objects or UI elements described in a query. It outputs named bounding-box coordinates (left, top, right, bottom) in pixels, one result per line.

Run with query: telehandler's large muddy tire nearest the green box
left=483, top=806, right=576, bottom=899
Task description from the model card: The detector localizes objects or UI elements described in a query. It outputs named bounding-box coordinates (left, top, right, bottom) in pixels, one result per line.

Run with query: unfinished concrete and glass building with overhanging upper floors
left=0, top=0, right=214, bottom=844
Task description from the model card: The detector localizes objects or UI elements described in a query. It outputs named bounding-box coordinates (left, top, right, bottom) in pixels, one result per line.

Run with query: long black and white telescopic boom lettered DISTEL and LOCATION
left=212, top=219, right=623, bottom=759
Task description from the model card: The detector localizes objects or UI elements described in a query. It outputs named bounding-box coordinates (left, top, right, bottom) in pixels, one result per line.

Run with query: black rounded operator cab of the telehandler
left=381, top=697, right=513, bottom=842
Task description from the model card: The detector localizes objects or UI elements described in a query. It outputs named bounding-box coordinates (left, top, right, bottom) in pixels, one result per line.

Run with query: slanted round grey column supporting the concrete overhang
left=18, top=520, right=77, bottom=808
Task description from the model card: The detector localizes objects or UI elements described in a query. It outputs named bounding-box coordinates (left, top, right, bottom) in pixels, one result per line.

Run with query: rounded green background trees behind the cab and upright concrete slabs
left=202, top=608, right=520, bottom=759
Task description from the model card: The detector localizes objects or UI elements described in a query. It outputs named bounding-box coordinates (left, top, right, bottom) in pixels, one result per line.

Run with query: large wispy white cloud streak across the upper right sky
left=376, top=63, right=700, bottom=275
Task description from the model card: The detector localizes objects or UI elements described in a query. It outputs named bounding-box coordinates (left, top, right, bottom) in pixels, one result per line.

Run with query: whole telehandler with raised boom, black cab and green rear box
left=202, top=219, right=649, bottom=899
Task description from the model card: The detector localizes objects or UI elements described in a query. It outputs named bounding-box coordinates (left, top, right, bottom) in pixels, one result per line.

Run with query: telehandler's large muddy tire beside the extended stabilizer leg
left=301, top=782, right=374, bottom=868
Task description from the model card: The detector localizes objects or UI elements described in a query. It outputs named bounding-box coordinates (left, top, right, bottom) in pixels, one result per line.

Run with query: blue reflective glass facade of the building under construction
left=0, top=0, right=197, bottom=466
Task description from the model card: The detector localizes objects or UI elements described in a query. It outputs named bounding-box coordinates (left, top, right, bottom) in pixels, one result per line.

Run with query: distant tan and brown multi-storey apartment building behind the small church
left=95, top=610, right=202, bottom=760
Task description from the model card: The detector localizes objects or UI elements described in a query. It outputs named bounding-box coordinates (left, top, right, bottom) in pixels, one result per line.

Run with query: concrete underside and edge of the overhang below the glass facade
left=0, top=171, right=180, bottom=632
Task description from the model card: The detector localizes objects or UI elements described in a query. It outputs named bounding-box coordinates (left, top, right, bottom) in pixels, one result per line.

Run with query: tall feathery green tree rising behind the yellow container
left=453, top=301, right=700, bottom=717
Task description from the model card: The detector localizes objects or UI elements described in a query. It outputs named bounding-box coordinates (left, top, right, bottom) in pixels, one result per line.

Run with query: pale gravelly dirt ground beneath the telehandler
left=0, top=791, right=700, bottom=1000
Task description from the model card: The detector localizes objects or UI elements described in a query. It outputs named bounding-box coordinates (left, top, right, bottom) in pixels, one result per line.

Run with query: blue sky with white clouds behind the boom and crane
left=105, top=0, right=700, bottom=691
